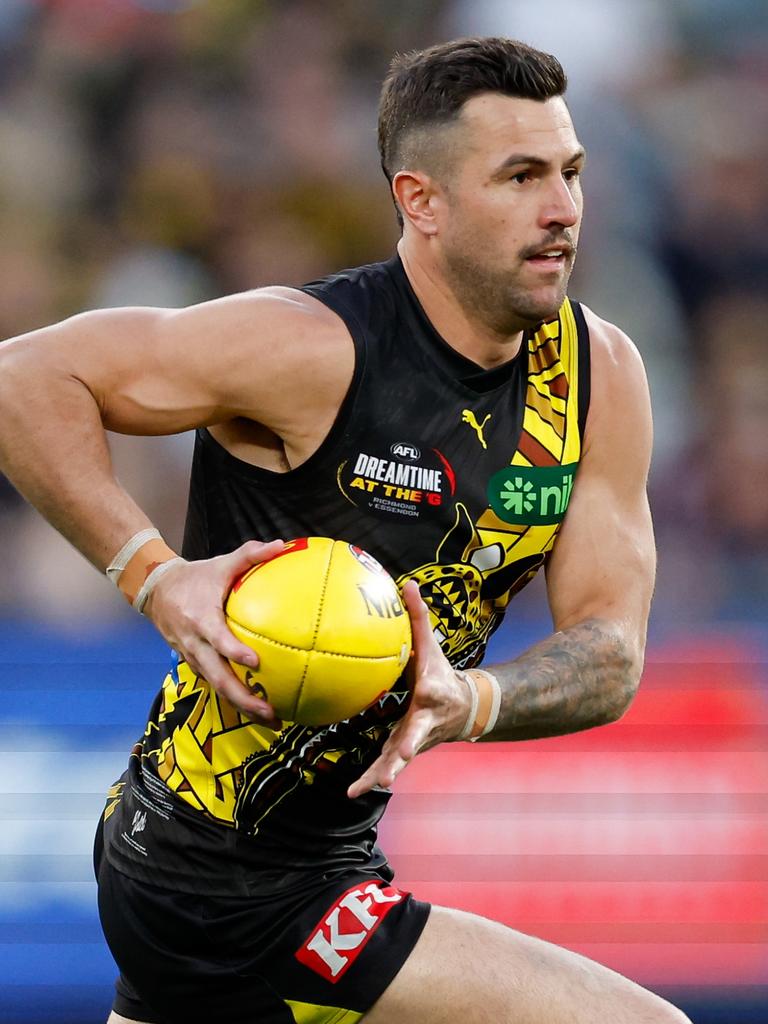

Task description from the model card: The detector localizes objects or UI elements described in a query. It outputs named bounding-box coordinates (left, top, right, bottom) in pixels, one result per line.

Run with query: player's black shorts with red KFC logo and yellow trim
left=96, top=823, right=429, bottom=1024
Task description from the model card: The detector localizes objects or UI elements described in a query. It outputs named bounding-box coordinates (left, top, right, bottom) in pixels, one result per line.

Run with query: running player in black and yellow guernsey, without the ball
left=0, top=39, right=686, bottom=1024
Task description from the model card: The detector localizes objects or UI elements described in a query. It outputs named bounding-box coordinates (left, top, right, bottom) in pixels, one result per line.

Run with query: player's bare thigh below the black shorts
left=364, top=906, right=690, bottom=1024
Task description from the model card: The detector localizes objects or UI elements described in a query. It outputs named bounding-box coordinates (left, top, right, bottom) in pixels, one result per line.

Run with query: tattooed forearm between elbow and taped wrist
left=486, top=618, right=640, bottom=740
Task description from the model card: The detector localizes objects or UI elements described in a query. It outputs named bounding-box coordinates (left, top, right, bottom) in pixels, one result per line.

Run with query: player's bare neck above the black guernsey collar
left=397, top=238, right=523, bottom=370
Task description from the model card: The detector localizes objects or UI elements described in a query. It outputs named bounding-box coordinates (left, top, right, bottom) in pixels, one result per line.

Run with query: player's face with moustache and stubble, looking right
left=435, top=93, right=584, bottom=333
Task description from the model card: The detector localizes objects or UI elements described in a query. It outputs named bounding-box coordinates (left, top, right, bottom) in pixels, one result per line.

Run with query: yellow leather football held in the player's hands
left=224, top=537, right=411, bottom=725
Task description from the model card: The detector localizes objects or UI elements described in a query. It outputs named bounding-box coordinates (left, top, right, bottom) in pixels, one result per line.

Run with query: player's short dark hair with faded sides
left=379, top=36, right=567, bottom=215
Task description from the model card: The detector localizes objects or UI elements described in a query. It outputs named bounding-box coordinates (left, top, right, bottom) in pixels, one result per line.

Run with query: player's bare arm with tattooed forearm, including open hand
left=348, top=311, right=655, bottom=797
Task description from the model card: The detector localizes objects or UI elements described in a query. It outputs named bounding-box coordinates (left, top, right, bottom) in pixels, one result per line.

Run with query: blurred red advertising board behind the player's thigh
left=382, top=641, right=768, bottom=986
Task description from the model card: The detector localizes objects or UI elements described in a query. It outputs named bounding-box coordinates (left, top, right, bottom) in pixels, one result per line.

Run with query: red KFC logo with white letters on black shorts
left=296, top=882, right=408, bottom=984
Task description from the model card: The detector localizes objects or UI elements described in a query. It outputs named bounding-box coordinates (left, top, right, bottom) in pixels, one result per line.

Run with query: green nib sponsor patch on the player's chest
left=487, top=462, right=579, bottom=526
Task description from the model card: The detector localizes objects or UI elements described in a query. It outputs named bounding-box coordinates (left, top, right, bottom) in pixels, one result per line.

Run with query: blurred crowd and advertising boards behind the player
left=0, top=0, right=768, bottom=1024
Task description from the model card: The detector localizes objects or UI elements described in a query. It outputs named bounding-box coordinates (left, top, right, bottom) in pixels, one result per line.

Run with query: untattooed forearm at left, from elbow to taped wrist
left=0, top=339, right=150, bottom=569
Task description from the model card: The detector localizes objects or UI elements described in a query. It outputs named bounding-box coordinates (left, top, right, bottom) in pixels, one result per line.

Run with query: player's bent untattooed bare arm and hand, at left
left=0, top=289, right=353, bottom=717
